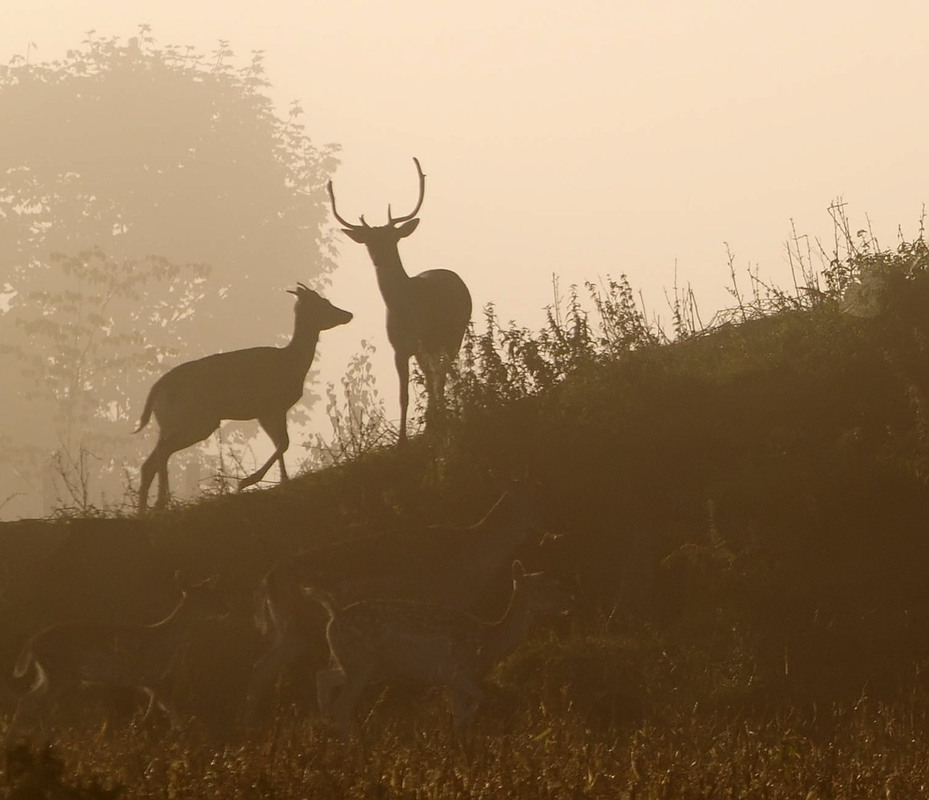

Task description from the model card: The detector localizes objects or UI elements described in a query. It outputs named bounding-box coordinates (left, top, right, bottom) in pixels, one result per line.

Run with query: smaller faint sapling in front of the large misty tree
left=0, top=249, right=203, bottom=512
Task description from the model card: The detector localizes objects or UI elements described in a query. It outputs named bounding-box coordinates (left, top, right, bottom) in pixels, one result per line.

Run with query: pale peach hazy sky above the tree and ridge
left=0, top=0, right=929, bottom=422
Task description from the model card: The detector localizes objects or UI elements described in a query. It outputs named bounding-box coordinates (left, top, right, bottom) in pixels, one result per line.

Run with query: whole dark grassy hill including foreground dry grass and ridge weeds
left=0, top=231, right=929, bottom=797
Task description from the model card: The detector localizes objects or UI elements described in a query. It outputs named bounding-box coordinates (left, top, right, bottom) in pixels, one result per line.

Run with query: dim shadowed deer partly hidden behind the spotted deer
left=245, top=482, right=540, bottom=722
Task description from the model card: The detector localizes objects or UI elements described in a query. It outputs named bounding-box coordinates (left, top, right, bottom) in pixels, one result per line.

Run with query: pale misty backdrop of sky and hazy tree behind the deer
left=0, top=0, right=929, bottom=518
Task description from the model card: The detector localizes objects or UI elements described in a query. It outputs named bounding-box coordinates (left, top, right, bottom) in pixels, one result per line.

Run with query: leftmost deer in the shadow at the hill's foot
left=6, top=578, right=229, bottom=741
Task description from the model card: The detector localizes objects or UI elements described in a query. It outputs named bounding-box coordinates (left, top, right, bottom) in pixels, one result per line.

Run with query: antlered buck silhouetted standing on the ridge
left=329, top=158, right=471, bottom=442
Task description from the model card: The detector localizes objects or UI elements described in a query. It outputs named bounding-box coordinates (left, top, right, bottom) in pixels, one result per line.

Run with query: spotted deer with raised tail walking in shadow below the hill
left=316, top=561, right=572, bottom=738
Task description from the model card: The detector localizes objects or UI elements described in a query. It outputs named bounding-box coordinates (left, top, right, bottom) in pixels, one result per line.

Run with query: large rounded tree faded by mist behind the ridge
left=0, top=26, right=336, bottom=513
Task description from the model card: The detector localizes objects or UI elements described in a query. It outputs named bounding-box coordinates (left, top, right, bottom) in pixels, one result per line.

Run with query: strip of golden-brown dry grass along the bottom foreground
left=5, top=700, right=929, bottom=800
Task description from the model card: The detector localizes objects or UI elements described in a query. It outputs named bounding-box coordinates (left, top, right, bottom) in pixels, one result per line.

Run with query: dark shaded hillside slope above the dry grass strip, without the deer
left=0, top=252, right=929, bottom=725
